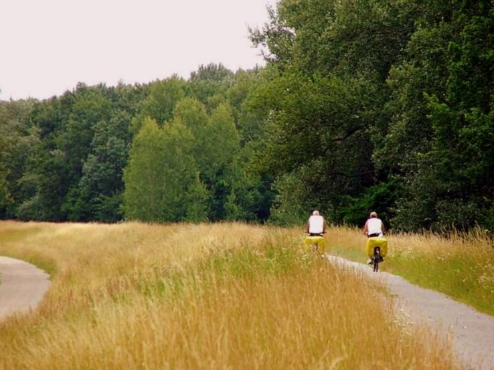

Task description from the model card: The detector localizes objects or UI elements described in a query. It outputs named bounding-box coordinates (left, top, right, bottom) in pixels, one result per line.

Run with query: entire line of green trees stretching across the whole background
left=0, top=0, right=494, bottom=231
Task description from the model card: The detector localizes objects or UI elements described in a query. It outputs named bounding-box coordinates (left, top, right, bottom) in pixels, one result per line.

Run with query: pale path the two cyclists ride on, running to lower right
left=326, top=255, right=494, bottom=370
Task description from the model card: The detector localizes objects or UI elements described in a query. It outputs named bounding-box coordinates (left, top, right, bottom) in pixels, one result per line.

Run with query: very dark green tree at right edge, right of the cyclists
left=376, top=1, right=493, bottom=230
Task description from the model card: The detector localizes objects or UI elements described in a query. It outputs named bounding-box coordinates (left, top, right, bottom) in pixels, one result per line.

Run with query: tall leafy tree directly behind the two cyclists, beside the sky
left=251, top=0, right=414, bottom=220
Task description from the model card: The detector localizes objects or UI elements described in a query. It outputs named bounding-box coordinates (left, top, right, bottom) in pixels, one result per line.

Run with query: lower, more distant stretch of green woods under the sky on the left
left=0, top=65, right=272, bottom=222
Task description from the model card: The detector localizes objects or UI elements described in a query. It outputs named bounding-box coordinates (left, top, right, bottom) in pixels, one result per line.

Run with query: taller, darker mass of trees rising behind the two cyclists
left=251, top=0, right=494, bottom=230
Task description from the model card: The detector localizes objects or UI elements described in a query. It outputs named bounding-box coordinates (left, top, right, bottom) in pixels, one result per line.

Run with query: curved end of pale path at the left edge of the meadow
left=0, top=257, right=50, bottom=320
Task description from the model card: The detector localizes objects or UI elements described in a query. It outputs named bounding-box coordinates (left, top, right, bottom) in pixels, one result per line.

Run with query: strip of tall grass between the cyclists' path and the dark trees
left=328, top=227, right=494, bottom=315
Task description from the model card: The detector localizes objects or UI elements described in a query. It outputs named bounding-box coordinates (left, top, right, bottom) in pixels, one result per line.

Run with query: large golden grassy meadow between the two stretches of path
left=0, top=221, right=460, bottom=370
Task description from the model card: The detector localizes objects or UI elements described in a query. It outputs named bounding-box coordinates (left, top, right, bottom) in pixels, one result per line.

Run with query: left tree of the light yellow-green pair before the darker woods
left=124, top=118, right=201, bottom=222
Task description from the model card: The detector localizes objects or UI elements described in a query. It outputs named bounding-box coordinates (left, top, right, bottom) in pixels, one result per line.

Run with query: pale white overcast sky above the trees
left=0, top=0, right=276, bottom=100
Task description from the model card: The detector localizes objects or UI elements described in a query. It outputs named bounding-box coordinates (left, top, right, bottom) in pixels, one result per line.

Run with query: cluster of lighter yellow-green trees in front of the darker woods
left=124, top=98, right=244, bottom=222
